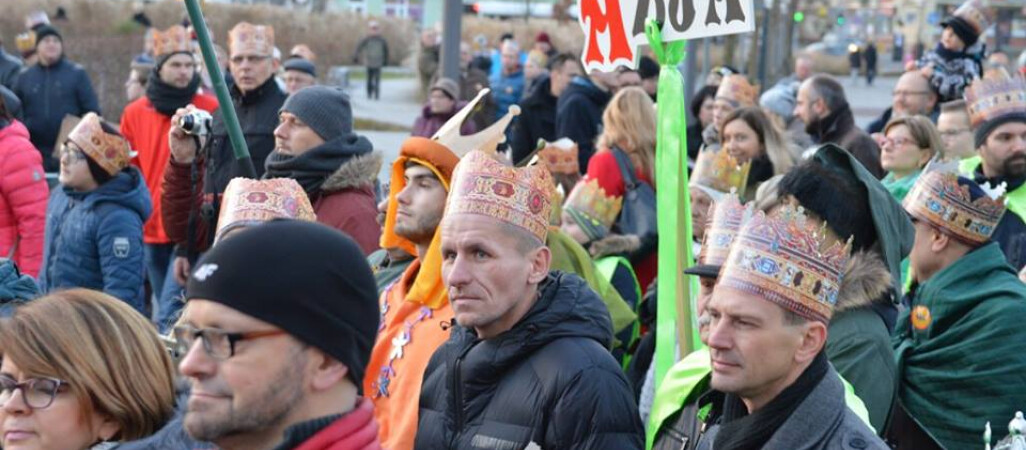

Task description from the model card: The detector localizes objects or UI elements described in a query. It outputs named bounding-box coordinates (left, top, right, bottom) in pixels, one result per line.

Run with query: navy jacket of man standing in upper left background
left=11, top=57, right=100, bottom=172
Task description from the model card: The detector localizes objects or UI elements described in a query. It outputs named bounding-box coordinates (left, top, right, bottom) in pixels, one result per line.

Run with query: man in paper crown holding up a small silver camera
left=161, top=22, right=286, bottom=283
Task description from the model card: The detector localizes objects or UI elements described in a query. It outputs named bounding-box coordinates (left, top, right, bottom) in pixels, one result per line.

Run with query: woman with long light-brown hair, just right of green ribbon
left=719, top=107, right=797, bottom=199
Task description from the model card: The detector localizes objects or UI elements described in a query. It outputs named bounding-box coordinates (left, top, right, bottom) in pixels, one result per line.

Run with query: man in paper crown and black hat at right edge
left=959, top=72, right=1026, bottom=271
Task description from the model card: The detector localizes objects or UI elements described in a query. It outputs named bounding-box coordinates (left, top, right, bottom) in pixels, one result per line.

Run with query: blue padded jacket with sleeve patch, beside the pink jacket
left=39, top=167, right=153, bottom=312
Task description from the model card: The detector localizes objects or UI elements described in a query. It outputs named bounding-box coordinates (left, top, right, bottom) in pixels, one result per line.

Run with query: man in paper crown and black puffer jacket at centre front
left=416, top=152, right=642, bottom=449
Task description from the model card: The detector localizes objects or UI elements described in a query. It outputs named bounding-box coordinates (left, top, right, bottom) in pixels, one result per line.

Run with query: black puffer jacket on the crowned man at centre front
left=416, top=272, right=644, bottom=450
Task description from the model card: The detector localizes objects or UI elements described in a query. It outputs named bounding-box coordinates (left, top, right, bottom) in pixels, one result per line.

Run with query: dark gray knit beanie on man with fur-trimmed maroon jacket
left=278, top=86, right=353, bottom=140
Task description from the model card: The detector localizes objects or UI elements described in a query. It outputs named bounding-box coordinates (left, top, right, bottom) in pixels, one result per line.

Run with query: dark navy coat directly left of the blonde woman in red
left=556, top=76, right=613, bottom=173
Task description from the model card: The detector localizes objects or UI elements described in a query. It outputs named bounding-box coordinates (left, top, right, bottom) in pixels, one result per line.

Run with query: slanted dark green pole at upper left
left=185, top=0, right=257, bottom=178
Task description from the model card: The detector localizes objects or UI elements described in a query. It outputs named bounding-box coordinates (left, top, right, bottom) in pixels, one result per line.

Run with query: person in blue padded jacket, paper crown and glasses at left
left=39, top=113, right=152, bottom=314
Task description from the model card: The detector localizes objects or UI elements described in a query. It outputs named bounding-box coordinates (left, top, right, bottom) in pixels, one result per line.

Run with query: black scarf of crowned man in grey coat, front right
left=712, top=352, right=830, bottom=450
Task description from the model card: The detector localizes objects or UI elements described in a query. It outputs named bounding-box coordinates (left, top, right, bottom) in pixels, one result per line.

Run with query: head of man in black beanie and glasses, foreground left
left=174, top=220, right=383, bottom=450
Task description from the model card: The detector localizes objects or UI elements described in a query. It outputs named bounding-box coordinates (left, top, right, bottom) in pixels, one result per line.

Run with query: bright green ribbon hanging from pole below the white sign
left=645, top=18, right=701, bottom=426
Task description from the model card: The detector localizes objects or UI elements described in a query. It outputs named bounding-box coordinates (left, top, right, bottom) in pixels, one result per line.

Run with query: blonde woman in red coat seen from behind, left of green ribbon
left=587, top=86, right=658, bottom=290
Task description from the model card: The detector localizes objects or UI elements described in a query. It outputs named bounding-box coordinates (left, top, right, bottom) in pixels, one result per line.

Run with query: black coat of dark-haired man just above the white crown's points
left=510, top=75, right=558, bottom=164
